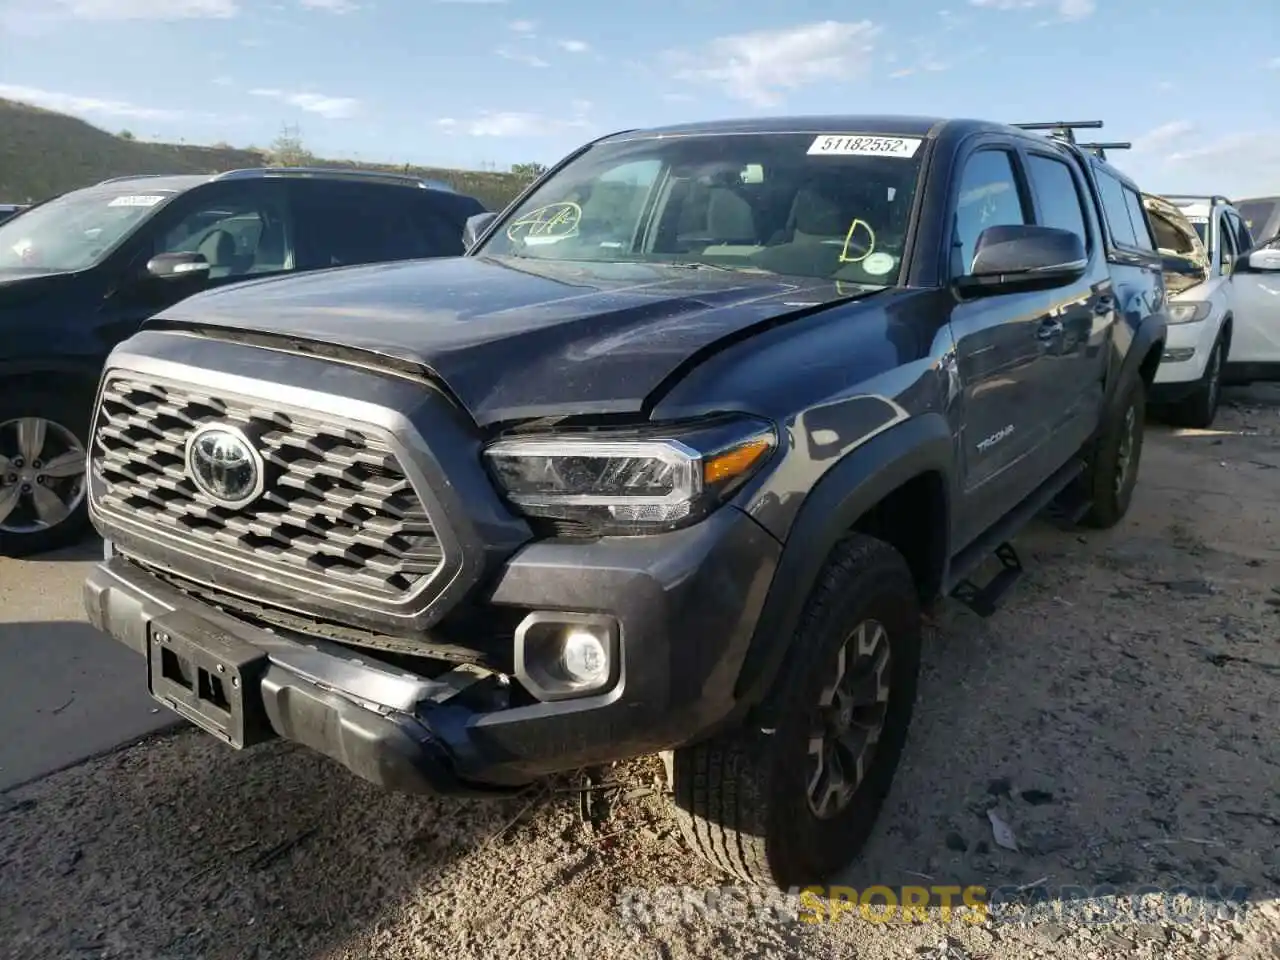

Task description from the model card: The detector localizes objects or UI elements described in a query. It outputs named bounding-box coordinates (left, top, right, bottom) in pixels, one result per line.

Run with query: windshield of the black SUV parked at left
left=0, top=188, right=173, bottom=273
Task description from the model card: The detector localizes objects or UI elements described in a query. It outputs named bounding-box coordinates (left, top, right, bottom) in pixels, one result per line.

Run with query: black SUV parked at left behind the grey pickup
left=0, top=169, right=484, bottom=556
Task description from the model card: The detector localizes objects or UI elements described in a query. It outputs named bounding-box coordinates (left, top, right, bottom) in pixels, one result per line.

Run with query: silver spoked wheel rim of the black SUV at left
left=0, top=417, right=84, bottom=535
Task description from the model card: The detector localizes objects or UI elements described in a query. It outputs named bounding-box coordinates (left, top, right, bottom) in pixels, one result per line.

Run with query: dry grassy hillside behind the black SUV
left=0, top=100, right=526, bottom=210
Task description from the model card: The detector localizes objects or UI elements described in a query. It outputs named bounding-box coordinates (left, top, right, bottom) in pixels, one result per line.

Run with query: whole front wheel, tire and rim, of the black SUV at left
left=0, top=383, right=91, bottom=557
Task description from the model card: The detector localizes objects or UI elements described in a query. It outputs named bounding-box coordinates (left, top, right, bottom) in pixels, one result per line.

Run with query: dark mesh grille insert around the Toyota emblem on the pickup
left=92, top=374, right=442, bottom=600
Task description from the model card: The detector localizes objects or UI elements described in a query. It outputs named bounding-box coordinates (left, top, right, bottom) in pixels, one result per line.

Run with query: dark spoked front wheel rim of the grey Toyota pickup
left=808, top=620, right=890, bottom=819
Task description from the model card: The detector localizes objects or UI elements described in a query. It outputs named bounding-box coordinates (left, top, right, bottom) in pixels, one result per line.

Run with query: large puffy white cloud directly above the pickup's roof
left=675, top=20, right=879, bottom=106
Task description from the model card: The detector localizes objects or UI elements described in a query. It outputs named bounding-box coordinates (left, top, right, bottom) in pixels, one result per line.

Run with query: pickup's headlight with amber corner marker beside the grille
left=484, top=419, right=777, bottom=535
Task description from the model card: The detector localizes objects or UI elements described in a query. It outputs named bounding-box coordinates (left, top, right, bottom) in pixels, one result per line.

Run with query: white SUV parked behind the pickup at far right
left=1143, top=196, right=1280, bottom=428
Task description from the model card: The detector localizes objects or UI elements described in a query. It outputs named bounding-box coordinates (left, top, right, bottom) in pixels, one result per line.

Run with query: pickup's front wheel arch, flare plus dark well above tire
left=735, top=413, right=955, bottom=726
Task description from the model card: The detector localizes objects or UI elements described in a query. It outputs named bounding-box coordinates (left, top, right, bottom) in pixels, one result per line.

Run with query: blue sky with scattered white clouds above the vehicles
left=0, top=0, right=1280, bottom=196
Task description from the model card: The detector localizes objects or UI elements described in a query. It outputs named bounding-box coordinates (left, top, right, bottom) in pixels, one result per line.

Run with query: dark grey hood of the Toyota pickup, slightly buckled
left=151, top=257, right=882, bottom=426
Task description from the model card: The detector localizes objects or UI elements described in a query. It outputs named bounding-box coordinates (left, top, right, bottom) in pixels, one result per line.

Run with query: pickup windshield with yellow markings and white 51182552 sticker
left=475, top=133, right=924, bottom=285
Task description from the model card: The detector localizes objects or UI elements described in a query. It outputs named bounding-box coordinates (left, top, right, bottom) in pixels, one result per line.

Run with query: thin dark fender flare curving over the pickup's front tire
left=735, top=413, right=955, bottom=726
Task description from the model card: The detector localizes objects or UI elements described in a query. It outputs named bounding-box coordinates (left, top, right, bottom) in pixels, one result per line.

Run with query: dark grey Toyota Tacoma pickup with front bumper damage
left=86, top=116, right=1165, bottom=886
